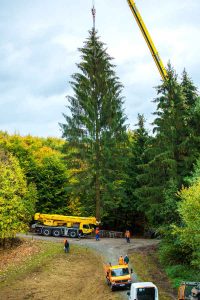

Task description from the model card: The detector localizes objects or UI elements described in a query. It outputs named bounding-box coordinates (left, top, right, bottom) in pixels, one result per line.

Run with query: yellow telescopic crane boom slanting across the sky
left=127, top=0, right=167, bottom=80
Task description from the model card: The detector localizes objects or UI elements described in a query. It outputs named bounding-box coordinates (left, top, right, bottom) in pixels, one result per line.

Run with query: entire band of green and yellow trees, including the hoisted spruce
left=0, top=30, right=200, bottom=280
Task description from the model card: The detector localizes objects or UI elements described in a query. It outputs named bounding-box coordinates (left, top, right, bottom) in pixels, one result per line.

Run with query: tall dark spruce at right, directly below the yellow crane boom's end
left=136, top=65, right=187, bottom=226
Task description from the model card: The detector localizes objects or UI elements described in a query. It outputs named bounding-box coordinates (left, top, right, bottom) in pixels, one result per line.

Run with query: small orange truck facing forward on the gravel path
left=104, top=264, right=132, bottom=291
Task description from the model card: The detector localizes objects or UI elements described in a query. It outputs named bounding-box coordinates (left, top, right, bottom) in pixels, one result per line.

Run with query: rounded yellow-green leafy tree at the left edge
left=0, top=151, right=33, bottom=238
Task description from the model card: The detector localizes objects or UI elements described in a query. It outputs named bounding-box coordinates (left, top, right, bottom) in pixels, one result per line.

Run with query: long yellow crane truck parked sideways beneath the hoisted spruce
left=32, top=213, right=99, bottom=238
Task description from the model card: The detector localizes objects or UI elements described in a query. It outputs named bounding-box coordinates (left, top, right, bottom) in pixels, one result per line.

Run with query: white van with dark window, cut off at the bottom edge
left=127, top=282, right=158, bottom=300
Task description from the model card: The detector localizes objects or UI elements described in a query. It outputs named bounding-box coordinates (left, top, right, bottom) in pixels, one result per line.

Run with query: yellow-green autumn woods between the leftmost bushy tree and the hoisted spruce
left=0, top=132, right=68, bottom=215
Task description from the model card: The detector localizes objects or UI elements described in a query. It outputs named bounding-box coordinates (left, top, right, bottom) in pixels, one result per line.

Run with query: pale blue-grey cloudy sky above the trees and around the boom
left=0, top=0, right=200, bottom=137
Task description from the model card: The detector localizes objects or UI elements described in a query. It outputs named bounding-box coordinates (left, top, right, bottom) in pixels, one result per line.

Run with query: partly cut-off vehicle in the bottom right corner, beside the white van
left=178, top=281, right=200, bottom=300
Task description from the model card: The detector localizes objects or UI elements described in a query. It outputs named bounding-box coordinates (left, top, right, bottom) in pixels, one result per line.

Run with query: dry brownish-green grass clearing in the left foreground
left=0, top=240, right=122, bottom=300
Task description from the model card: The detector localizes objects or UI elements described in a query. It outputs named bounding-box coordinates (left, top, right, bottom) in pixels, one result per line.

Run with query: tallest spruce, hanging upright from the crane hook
left=61, top=29, right=127, bottom=219
